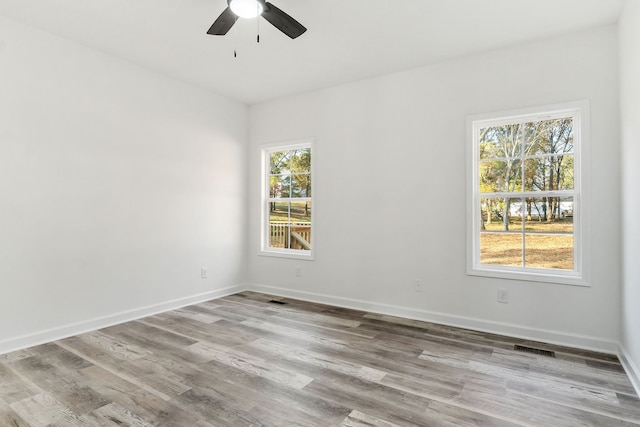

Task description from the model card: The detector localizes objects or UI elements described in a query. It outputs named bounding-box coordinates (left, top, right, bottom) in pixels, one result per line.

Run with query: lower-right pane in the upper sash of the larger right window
left=525, top=154, right=573, bottom=191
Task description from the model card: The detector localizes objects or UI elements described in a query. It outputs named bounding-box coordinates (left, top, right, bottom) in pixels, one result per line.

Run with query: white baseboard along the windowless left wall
left=0, top=285, right=245, bottom=354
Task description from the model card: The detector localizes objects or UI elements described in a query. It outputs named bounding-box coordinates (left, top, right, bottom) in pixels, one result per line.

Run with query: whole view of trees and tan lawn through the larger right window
left=479, top=117, right=574, bottom=270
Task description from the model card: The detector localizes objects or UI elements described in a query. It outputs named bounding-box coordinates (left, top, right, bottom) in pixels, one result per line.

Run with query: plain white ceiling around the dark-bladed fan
left=0, top=0, right=624, bottom=104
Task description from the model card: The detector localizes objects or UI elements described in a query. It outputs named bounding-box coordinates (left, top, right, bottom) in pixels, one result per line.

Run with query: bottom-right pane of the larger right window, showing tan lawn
left=525, top=234, right=573, bottom=270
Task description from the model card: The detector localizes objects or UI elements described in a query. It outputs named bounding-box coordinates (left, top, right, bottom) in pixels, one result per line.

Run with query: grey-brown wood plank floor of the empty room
left=0, top=292, right=640, bottom=427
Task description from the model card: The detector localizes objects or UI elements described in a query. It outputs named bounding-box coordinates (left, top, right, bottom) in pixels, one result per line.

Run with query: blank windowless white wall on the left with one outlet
left=0, top=18, right=248, bottom=353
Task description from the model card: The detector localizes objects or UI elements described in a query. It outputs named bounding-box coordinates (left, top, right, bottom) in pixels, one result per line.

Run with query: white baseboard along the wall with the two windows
left=247, top=284, right=619, bottom=354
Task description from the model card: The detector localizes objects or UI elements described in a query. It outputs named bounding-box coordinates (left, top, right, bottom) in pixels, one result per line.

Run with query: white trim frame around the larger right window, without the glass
left=466, top=100, right=591, bottom=286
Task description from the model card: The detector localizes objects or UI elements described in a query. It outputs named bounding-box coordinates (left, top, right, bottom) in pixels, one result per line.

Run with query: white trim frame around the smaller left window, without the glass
left=258, top=138, right=317, bottom=261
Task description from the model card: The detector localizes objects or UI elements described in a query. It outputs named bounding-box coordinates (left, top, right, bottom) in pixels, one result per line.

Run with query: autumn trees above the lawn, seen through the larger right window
left=480, top=118, right=574, bottom=230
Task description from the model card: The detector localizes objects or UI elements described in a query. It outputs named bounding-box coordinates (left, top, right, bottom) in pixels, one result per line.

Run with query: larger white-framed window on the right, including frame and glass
left=467, top=102, right=588, bottom=285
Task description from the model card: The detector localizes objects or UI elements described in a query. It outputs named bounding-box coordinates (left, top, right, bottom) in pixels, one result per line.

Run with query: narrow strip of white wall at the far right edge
left=620, top=1, right=640, bottom=393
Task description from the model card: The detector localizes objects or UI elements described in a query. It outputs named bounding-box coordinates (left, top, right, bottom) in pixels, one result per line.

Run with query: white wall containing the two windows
left=249, top=26, right=621, bottom=351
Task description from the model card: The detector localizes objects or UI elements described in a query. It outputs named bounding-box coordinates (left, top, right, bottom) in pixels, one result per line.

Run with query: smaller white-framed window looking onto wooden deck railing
left=262, top=141, right=313, bottom=259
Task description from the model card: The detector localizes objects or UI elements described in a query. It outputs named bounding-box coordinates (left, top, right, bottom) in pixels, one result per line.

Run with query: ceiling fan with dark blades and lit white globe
left=207, top=0, right=307, bottom=39
